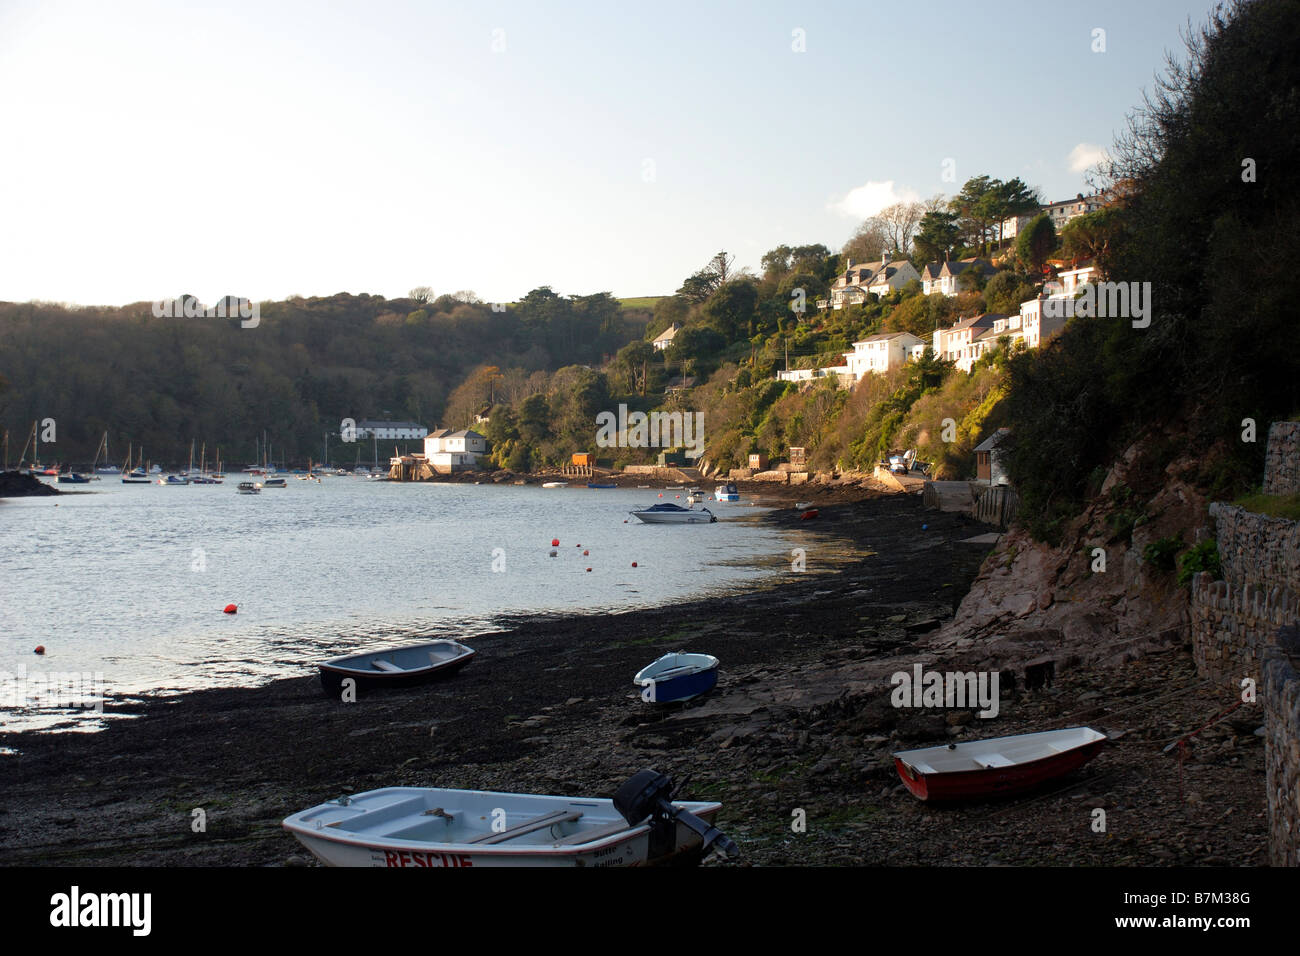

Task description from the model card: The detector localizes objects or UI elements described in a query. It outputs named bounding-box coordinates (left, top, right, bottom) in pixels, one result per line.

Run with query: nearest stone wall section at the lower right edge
left=1261, top=627, right=1300, bottom=866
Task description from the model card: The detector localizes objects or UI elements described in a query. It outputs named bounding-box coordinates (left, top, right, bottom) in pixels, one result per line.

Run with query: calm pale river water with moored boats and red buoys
left=0, top=476, right=797, bottom=730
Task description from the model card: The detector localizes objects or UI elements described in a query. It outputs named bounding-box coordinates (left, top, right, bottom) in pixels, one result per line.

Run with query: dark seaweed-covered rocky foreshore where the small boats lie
left=0, top=486, right=1268, bottom=865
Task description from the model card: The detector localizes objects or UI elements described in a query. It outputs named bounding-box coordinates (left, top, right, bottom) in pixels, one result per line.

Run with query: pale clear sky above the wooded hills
left=0, top=0, right=1212, bottom=304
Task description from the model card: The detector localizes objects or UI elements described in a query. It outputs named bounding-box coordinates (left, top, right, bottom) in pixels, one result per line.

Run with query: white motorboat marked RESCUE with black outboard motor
left=283, top=770, right=736, bottom=869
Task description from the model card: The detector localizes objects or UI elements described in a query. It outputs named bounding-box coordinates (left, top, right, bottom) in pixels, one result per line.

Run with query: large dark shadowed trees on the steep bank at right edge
left=1006, top=0, right=1300, bottom=540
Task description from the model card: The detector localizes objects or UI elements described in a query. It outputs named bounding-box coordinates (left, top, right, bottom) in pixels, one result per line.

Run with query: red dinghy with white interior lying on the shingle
left=893, top=727, right=1106, bottom=803
